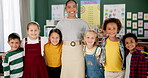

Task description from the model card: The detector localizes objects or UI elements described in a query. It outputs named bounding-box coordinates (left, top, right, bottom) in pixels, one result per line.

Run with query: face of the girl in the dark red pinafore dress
left=27, top=24, right=40, bottom=40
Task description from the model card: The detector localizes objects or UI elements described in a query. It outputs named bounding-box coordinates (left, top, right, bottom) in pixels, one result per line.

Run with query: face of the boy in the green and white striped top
left=8, top=39, right=21, bottom=50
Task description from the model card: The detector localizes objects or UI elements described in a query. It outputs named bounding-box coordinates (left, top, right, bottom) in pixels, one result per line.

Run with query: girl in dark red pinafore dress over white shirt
left=22, top=22, right=48, bottom=78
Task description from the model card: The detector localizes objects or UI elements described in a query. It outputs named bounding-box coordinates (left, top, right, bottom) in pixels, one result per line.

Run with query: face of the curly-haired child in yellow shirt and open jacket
left=105, top=22, right=118, bottom=37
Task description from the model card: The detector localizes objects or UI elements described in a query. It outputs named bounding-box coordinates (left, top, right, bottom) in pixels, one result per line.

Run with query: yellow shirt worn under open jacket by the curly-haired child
left=105, top=38, right=122, bottom=72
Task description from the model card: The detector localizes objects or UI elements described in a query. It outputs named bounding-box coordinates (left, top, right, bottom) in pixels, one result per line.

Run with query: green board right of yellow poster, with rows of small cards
left=100, top=0, right=148, bottom=37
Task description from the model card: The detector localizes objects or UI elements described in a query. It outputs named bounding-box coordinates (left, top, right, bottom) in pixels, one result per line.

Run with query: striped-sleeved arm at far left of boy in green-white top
left=2, top=57, right=10, bottom=78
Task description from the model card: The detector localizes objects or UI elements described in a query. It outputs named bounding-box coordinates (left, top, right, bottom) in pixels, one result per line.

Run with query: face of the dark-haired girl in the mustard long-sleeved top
left=49, top=32, right=60, bottom=46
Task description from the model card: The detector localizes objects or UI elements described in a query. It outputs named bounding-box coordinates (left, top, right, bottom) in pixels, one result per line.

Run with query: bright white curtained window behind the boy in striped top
left=0, top=0, right=22, bottom=52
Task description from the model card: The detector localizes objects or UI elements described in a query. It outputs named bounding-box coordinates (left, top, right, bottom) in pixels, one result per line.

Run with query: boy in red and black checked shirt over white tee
left=123, top=33, right=147, bottom=78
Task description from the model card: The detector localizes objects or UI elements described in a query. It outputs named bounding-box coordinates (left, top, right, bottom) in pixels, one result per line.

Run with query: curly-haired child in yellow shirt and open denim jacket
left=100, top=18, right=125, bottom=78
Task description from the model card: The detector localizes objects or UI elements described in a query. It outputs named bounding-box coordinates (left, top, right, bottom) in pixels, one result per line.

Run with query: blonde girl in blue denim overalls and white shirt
left=84, top=30, right=104, bottom=78
